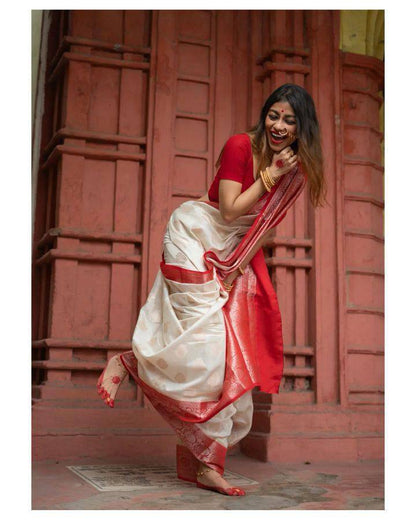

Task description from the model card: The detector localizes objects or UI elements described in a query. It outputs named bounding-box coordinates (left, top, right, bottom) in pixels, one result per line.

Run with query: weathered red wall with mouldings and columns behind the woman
left=33, top=10, right=383, bottom=460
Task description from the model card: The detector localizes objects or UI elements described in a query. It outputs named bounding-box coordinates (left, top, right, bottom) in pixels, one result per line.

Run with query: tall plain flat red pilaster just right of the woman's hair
left=308, top=11, right=339, bottom=403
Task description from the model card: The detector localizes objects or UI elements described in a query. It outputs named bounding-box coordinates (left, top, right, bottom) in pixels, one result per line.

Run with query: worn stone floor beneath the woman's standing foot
left=32, top=453, right=384, bottom=510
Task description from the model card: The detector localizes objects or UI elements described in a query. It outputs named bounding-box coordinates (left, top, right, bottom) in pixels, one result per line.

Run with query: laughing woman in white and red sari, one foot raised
left=98, top=84, right=324, bottom=495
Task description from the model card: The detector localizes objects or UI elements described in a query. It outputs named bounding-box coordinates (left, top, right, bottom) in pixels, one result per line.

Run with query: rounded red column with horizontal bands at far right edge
left=342, top=53, right=384, bottom=416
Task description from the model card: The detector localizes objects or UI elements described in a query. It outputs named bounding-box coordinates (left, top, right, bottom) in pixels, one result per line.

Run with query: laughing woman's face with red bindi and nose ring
left=265, top=101, right=296, bottom=153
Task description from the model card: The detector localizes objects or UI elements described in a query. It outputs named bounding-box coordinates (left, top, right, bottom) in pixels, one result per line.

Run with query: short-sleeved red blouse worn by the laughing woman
left=208, top=134, right=254, bottom=202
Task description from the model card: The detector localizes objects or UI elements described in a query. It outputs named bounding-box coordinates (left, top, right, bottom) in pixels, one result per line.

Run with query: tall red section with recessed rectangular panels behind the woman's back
left=147, top=11, right=217, bottom=290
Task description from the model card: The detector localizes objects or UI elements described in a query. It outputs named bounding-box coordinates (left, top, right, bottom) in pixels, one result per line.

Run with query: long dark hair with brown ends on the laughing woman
left=248, top=83, right=326, bottom=207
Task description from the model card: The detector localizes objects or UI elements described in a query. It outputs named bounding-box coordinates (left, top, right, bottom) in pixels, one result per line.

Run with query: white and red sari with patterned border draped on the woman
left=121, top=168, right=306, bottom=474
